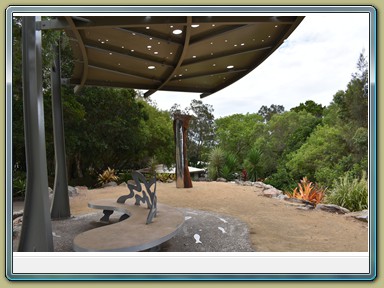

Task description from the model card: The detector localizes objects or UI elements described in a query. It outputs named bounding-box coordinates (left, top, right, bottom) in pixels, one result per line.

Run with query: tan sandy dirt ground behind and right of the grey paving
left=71, top=182, right=368, bottom=252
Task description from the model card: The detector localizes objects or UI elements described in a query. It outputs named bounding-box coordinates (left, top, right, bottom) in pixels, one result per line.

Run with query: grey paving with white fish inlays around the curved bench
left=13, top=209, right=254, bottom=252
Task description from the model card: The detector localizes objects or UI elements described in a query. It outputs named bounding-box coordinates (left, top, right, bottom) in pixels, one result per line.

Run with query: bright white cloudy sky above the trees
left=143, top=13, right=369, bottom=119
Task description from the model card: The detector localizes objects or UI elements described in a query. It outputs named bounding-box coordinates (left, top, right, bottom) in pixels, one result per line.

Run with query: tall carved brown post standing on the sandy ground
left=173, top=114, right=192, bottom=188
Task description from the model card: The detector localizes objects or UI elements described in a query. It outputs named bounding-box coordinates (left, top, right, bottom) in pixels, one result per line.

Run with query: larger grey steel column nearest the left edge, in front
left=18, top=17, right=53, bottom=252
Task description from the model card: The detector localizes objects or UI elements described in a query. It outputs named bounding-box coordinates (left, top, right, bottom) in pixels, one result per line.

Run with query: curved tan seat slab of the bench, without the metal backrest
left=73, top=199, right=185, bottom=252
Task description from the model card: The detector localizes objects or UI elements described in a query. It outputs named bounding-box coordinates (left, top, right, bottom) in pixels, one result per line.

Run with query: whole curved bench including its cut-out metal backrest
left=73, top=172, right=185, bottom=252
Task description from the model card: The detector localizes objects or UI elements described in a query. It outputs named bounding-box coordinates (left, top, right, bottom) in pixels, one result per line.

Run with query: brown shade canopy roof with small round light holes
left=41, top=16, right=304, bottom=97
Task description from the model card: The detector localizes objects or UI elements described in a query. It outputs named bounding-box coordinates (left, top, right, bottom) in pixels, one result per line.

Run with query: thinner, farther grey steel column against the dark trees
left=51, top=45, right=71, bottom=219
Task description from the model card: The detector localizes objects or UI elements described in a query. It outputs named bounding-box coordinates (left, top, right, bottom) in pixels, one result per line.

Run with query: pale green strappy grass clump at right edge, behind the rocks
left=326, top=172, right=368, bottom=211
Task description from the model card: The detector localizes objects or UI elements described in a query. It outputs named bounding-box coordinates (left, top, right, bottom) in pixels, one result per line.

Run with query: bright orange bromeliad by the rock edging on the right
left=288, top=177, right=326, bottom=205
